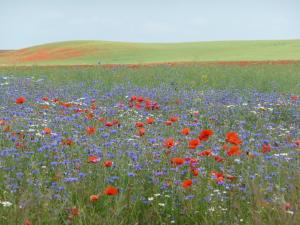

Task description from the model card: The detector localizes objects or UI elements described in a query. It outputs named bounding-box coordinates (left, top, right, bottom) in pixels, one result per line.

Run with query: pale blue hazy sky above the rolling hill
left=0, top=0, right=300, bottom=49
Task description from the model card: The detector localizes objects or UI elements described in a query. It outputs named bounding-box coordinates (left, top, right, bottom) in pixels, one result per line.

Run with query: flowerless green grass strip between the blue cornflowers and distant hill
left=0, top=63, right=300, bottom=94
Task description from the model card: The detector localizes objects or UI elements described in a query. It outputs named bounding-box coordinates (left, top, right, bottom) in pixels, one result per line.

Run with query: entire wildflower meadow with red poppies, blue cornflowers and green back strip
left=0, top=63, right=300, bottom=225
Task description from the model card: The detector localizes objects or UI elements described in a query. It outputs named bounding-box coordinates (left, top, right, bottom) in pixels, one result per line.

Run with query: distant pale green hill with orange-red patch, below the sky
left=0, top=40, right=300, bottom=65
